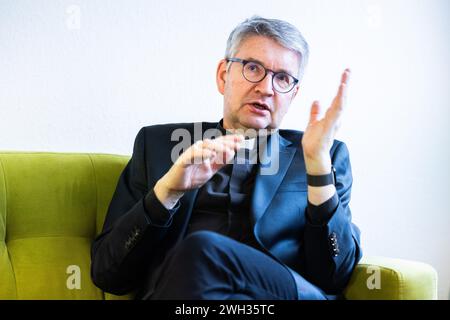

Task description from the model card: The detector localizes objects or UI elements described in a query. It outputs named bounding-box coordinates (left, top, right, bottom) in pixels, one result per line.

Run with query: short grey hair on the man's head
left=225, top=16, right=309, bottom=80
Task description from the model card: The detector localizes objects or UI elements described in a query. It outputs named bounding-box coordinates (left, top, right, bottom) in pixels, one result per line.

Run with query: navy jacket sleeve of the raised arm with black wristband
left=304, top=141, right=362, bottom=294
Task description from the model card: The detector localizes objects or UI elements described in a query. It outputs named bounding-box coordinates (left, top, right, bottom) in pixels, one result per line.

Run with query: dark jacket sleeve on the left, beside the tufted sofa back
left=91, top=128, right=178, bottom=295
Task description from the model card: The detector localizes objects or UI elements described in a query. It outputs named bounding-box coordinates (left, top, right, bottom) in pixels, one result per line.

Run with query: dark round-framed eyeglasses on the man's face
left=226, top=58, right=299, bottom=93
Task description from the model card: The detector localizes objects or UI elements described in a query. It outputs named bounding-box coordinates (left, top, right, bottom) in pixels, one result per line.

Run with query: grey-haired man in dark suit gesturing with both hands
left=91, top=17, right=361, bottom=299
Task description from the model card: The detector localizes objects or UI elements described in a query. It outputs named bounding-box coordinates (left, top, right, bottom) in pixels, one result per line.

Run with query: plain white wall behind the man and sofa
left=0, top=0, right=450, bottom=299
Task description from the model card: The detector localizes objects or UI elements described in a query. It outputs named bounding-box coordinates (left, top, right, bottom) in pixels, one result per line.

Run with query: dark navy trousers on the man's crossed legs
left=145, top=231, right=326, bottom=300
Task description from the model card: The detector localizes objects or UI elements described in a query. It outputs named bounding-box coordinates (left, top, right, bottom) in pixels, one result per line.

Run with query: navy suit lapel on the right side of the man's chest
left=250, top=132, right=297, bottom=223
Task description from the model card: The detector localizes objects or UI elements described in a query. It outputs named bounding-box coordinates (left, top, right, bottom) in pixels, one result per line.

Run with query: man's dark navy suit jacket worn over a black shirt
left=91, top=123, right=361, bottom=295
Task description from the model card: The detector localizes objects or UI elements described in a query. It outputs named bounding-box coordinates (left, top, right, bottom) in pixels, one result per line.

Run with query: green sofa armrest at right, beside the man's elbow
left=344, top=257, right=437, bottom=300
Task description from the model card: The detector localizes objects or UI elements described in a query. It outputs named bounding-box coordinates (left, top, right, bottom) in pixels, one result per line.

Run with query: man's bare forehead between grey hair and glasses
left=235, top=36, right=300, bottom=74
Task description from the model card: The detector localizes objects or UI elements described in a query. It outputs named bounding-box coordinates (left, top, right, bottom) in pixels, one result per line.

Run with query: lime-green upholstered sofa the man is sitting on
left=0, top=151, right=437, bottom=299
